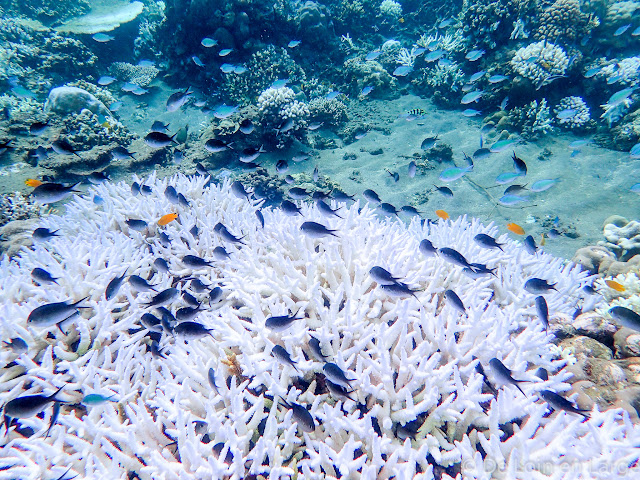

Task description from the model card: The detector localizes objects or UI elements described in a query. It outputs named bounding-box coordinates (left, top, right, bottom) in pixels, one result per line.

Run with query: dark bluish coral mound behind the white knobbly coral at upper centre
left=223, top=45, right=306, bottom=105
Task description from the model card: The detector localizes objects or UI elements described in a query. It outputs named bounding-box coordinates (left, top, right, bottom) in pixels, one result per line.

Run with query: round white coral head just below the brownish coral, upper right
left=511, top=40, right=569, bottom=83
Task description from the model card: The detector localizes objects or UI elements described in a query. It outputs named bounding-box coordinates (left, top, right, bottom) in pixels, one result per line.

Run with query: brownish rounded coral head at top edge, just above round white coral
left=535, top=0, right=598, bottom=44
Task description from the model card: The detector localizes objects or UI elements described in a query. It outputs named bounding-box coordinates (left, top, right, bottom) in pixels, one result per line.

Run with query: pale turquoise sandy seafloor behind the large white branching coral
left=0, top=89, right=640, bottom=258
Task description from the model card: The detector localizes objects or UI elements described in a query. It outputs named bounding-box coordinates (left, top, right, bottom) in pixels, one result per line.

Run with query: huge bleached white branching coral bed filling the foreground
left=0, top=171, right=640, bottom=480
